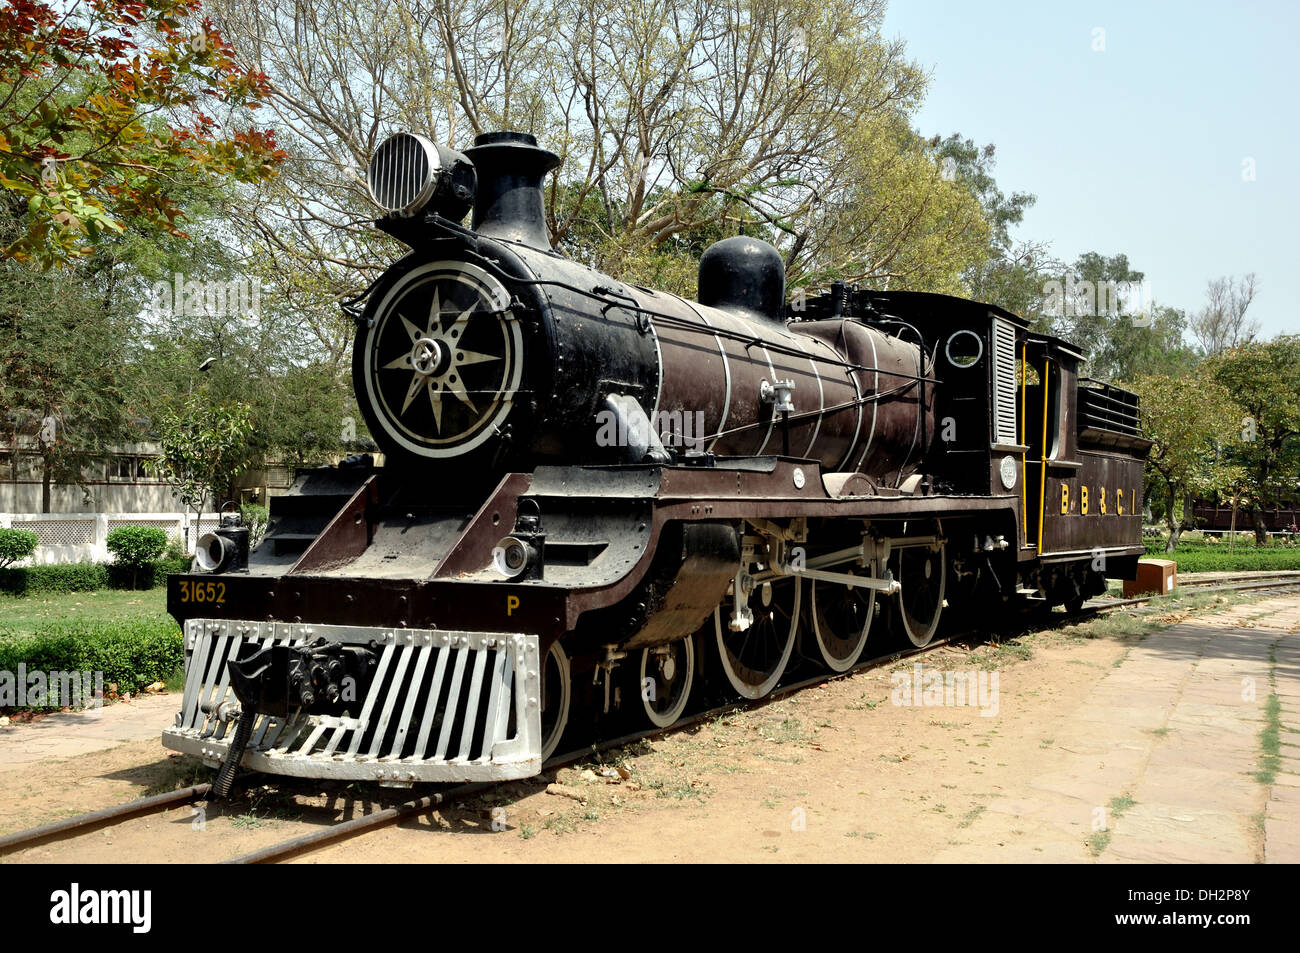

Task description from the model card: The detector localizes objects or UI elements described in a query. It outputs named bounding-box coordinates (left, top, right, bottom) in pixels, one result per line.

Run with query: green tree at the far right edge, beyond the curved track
left=1208, top=334, right=1300, bottom=546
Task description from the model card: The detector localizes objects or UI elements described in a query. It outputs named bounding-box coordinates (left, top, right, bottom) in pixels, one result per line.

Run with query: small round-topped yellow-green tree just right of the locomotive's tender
left=1132, top=374, right=1240, bottom=553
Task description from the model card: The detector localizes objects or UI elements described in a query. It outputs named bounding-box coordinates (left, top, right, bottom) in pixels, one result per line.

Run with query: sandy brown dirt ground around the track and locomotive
left=0, top=587, right=1296, bottom=863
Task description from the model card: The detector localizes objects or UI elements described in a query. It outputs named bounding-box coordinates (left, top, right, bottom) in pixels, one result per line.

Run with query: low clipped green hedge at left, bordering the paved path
left=0, top=616, right=185, bottom=709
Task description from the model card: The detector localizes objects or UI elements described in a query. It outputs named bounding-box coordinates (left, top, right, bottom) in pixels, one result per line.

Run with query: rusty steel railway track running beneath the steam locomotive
left=0, top=572, right=1300, bottom=865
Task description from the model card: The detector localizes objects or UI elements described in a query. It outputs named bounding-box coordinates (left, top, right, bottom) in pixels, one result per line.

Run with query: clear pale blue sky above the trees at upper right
left=884, top=0, right=1300, bottom=337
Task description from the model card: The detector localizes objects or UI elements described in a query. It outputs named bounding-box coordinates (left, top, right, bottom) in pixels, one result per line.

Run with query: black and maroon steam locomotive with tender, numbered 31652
left=164, top=133, right=1149, bottom=792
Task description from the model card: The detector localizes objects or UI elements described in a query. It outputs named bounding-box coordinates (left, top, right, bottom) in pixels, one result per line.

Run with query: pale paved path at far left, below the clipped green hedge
left=0, top=694, right=181, bottom=777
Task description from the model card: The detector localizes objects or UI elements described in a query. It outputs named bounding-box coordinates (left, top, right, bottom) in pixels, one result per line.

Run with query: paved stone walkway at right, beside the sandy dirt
left=935, top=595, right=1300, bottom=863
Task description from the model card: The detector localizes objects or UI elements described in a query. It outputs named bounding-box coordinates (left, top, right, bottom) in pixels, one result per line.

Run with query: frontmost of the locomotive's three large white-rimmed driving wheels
left=714, top=576, right=800, bottom=698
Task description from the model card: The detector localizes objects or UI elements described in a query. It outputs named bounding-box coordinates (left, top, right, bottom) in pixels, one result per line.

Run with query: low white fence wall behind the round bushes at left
left=0, top=512, right=218, bottom=566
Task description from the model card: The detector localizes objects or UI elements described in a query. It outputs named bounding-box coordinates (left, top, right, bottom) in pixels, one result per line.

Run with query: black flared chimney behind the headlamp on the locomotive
left=465, top=133, right=560, bottom=251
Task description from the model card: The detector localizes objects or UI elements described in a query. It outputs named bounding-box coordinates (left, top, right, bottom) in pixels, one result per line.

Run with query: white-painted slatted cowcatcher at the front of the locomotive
left=163, top=619, right=542, bottom=787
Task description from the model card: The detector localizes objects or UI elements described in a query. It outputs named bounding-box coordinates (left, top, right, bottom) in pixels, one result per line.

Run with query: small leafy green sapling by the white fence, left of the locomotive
left=147, top=393, right=252, bottom=543
